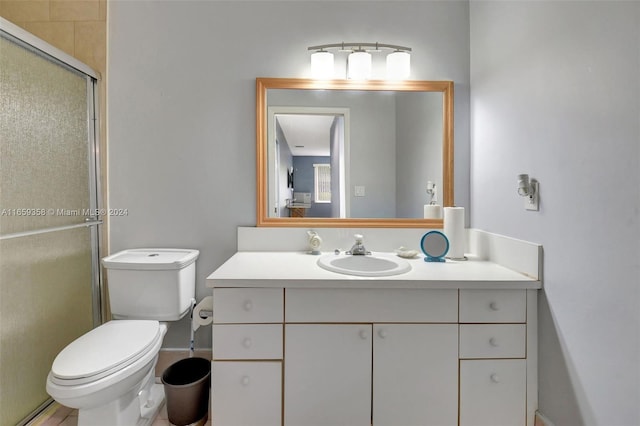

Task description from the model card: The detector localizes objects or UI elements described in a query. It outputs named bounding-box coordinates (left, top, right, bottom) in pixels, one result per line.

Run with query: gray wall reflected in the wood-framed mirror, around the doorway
left=267, top=89, right=443, bottom=218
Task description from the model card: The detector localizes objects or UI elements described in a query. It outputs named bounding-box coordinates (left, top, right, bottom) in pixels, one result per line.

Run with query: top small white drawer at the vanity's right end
left=460, top=290, right=527, bottom=323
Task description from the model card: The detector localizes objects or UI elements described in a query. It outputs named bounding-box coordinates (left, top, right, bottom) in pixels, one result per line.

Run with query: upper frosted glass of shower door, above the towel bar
left=0, top=38, right=89, bottom=235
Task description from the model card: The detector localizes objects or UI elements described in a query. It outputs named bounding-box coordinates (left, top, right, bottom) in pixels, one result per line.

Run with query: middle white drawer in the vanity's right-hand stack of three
left=460, top=324, right=526, bottom=358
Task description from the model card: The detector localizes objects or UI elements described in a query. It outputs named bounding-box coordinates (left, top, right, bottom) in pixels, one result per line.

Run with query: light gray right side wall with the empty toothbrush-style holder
left=470, top=1, right=640, bottom=426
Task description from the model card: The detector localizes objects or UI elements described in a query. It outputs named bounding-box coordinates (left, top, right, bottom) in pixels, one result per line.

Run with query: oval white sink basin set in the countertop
left=318, top=253, right=411, bottom=277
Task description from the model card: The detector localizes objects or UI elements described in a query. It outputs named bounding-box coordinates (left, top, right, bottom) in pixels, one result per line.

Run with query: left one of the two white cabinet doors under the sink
left=284, top=324, right=371, bottom=426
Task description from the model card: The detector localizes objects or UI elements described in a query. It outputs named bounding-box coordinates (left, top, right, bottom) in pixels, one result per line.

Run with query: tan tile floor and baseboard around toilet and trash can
left=28, top=351, right=211, bottom=426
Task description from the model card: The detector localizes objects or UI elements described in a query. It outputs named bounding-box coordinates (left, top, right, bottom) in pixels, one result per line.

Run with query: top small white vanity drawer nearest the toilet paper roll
left=213, top=288, right=283, bottom=324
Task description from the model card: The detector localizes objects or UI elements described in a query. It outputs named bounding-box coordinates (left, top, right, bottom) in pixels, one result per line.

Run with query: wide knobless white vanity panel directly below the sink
left=285, top=288, right=458, bottom=323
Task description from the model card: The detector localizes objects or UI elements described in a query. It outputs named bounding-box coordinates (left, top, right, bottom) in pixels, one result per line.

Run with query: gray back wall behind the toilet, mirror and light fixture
left=108, top=0, right=469, bottom=347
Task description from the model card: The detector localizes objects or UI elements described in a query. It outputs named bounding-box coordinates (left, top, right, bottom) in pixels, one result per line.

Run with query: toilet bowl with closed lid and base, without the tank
left=47, top=320, right=167, bottom=426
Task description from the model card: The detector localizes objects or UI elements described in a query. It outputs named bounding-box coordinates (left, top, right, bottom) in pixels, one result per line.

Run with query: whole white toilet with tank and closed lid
left=47, top=249, right=199, bottom=426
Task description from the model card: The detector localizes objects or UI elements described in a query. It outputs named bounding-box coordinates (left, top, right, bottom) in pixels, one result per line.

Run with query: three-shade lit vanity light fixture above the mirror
left=307, top=42, right=411, bottom=80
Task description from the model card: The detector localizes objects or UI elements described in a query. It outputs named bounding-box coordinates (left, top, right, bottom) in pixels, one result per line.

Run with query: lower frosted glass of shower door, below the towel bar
left=0, top=228, right=93, bottom=425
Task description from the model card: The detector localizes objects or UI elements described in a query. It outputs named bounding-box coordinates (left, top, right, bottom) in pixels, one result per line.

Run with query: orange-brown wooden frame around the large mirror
left=256, top=78, right=454, bottom=228
